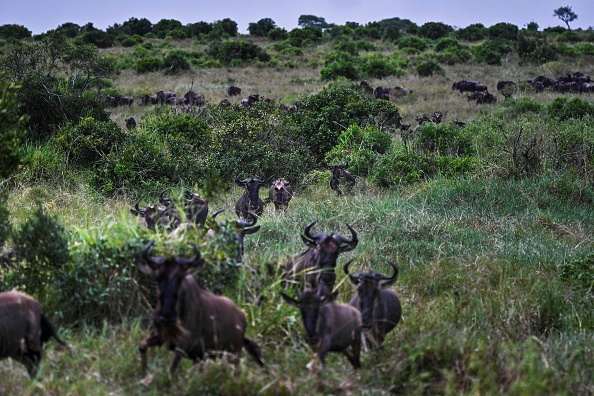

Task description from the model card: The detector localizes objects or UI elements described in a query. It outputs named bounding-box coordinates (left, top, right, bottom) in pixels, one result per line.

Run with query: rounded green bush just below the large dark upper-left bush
left=56, top=118, right=126, bottom=166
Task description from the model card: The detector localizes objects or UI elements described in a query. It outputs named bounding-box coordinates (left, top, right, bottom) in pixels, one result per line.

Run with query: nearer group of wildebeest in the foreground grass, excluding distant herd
left=0, top=164, right=402, bottom=378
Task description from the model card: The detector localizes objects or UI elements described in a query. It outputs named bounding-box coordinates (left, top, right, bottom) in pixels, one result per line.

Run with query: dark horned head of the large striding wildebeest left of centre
left=138, top=241, right=204, bottom=327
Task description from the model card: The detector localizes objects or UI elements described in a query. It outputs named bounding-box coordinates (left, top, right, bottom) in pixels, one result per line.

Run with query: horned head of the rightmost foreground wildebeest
left=343, top=260, right=398, bottom=331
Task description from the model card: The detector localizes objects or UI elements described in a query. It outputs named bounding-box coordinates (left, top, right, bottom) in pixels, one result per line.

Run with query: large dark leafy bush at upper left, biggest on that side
left=0, top=32, right=115, bottom=139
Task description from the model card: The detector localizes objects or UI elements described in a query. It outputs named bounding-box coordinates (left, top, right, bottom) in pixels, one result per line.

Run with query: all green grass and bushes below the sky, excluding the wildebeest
left=0, top=7, right=594, bottom=395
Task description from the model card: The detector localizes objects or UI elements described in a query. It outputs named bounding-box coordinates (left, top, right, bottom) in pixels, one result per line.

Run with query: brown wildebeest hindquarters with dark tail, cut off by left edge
left=0, top=290, right=70, bottom=377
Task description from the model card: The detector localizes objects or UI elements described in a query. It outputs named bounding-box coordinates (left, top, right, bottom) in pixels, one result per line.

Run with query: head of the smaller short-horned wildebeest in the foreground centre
left=281, top=284, right=336, bottom=345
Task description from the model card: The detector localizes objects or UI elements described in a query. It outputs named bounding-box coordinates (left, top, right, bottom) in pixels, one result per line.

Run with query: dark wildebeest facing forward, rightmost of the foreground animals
left=343, top=261, right=402, bottom=347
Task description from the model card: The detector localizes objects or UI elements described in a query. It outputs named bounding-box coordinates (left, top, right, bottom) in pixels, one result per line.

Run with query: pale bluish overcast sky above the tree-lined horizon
left=0, top=0, right=594, bottom=34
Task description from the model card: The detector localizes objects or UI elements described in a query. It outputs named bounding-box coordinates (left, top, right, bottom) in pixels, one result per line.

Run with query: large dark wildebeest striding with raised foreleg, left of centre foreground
left=138, top=241, right=264, bottom=377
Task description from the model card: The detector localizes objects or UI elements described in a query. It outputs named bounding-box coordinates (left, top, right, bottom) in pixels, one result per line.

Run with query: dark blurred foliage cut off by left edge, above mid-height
left=0, top=75, right=28, bottom=178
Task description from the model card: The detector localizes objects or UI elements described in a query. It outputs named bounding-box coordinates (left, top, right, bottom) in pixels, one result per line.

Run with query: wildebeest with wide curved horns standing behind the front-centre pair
left=284, top=221, right=359, bottom=291
